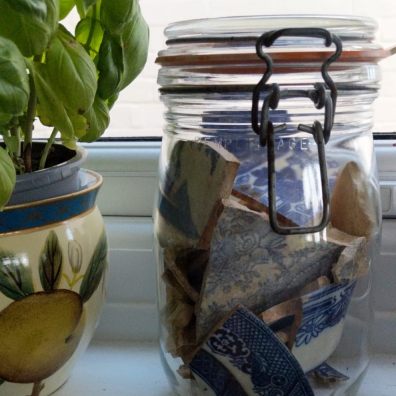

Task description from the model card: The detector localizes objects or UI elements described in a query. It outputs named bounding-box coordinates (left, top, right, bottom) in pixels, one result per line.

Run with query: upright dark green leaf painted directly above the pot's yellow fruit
left=39, top=231, right=63, bottom=292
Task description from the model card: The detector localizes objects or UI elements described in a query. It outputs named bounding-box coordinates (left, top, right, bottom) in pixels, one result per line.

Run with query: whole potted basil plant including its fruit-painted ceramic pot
left=0, top=0, right=149, bottom=396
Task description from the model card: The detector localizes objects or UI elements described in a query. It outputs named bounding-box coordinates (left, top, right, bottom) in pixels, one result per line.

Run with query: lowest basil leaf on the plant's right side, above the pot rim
left=80, top=96, right=110, bottom=142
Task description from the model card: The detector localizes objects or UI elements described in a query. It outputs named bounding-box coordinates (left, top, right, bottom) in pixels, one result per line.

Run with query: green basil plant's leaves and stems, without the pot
left=0, top=0, right=149, bottom=208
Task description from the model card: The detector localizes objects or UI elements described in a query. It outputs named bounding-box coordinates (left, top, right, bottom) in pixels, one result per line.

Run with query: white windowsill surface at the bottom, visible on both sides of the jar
left=57, top=343, right=396, bottom=396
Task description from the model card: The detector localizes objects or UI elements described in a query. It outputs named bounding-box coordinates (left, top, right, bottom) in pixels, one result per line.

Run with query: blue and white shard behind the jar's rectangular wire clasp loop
left=226, top=137, right=340, bottom=225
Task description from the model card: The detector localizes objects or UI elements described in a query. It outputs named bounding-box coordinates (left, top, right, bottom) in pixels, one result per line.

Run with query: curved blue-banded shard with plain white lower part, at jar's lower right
left=292, top=282, right=356, bottom=372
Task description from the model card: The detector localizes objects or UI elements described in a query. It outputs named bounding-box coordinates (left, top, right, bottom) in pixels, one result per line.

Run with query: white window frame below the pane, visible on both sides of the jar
left=83, top=134, right=396, bottom=217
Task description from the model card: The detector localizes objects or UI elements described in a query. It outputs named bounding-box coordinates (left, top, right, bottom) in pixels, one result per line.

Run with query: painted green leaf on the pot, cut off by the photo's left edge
left=0, top=250, right=34, bottom=300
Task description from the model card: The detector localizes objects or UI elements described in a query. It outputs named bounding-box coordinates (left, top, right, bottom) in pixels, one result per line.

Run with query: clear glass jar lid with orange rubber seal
left=157, top=15, right=391, bottom=74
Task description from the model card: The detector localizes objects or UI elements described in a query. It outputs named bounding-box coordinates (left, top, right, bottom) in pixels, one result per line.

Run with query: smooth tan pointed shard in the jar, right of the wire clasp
left=330, top=161, right=381, bottom=238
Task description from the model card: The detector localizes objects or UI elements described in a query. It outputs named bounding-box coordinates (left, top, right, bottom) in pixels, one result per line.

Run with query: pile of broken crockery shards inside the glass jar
left=155, top=140, right=380, bottom=395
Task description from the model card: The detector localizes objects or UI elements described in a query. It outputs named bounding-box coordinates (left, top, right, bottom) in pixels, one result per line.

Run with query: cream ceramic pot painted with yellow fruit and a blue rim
left=0, top=171, right=107, bottom=396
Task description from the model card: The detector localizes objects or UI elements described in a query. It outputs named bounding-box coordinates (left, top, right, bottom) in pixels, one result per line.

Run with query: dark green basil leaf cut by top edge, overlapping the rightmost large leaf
left=100, top=0, right=135, bottom=35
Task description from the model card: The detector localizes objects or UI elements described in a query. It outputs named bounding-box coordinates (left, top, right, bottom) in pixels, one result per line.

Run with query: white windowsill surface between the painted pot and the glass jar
left=56, top=342, right=173, bottom=396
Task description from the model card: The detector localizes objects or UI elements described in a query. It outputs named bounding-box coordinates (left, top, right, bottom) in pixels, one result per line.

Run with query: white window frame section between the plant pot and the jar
left=83, top=139, right=161, bottom=217
